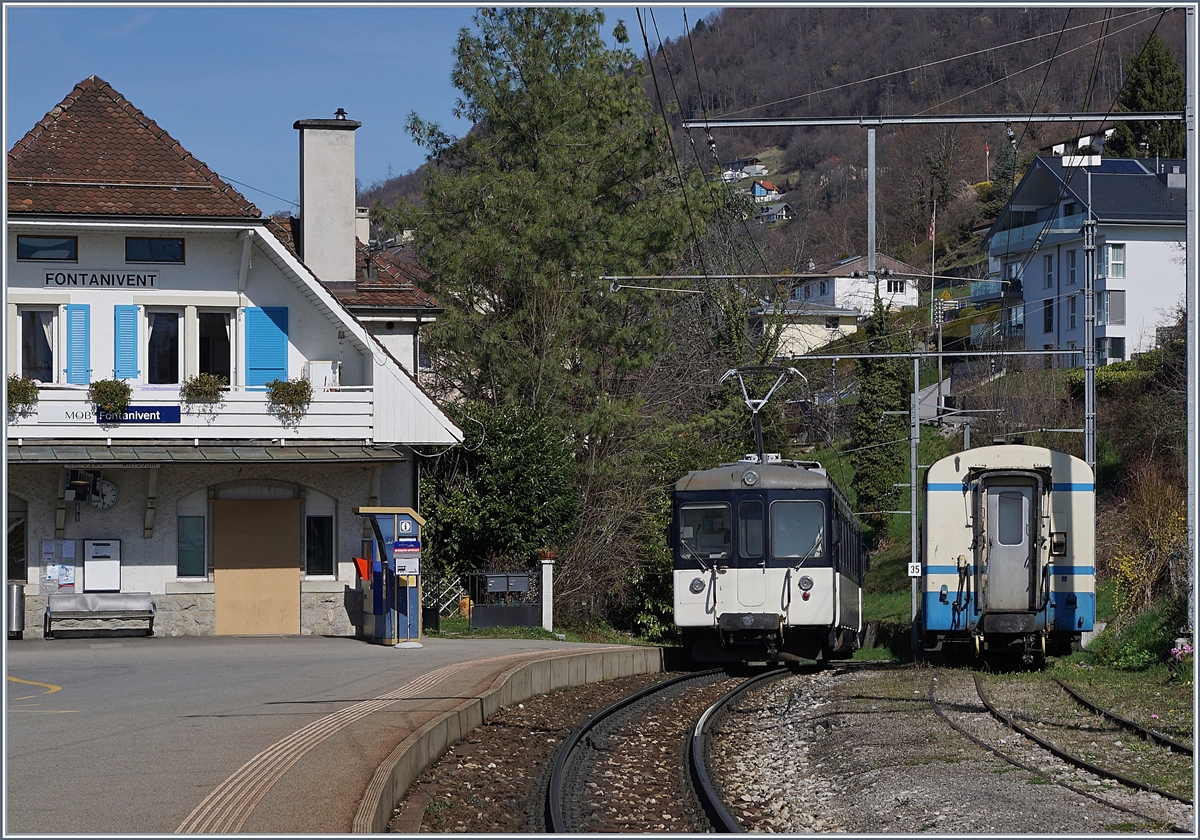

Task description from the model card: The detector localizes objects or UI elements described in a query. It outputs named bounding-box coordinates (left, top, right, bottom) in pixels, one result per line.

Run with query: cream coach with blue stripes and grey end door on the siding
left=920, top=444, right=1096, bottom=660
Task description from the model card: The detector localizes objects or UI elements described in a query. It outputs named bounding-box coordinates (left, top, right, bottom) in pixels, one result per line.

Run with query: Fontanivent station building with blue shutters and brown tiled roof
left=5, top=76, right=462, bottom=635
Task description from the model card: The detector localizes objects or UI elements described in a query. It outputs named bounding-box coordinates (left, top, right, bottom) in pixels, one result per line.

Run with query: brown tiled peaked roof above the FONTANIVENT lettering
left=8, top=76, right=262, bottom=218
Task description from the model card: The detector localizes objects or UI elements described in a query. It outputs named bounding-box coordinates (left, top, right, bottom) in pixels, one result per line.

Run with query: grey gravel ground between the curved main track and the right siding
left=710, top=666, right=1193, bottom=834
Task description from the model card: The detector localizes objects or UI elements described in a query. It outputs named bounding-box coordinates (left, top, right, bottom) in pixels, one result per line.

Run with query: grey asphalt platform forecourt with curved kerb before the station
left=5, top=637, right=662, bottom=834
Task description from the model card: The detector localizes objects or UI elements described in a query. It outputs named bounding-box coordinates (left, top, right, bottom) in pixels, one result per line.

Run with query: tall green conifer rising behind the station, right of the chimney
left=384, top=8, right=690, bottom=427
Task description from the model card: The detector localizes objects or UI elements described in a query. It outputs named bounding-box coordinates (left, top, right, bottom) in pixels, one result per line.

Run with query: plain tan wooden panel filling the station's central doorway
left=212, top=499, right=302, bottom=636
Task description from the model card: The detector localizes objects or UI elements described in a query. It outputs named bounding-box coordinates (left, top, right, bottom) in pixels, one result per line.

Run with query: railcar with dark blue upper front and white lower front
left=668, top=456, right=866, bottom=662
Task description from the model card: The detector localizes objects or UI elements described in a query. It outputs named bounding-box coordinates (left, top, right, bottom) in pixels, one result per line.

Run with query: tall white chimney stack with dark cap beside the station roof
left=292, top=108, right=362, bottom=284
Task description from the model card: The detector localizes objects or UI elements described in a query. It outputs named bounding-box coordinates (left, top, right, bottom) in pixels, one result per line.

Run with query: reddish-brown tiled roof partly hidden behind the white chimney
left=266, top=216, right=438, bottom=311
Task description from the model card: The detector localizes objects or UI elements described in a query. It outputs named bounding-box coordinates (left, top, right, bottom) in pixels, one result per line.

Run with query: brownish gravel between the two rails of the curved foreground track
left=563, top=677, right=739, bottom=833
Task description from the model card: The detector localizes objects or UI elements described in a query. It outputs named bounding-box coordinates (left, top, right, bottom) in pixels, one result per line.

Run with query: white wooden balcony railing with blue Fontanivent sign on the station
left=8, top=385, right=376, bottom=440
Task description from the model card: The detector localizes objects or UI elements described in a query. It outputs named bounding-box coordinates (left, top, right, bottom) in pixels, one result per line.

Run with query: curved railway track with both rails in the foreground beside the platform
left=546, top=670, right=786, bottom=834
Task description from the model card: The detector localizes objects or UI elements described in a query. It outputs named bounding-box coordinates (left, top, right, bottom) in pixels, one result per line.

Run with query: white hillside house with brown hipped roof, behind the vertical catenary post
left=791, top=253, right=929, bottom=316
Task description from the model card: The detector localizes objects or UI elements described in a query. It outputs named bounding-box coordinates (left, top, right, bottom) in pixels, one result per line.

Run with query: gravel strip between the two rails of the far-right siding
left=982, top=674, right=1193, bottom=798
